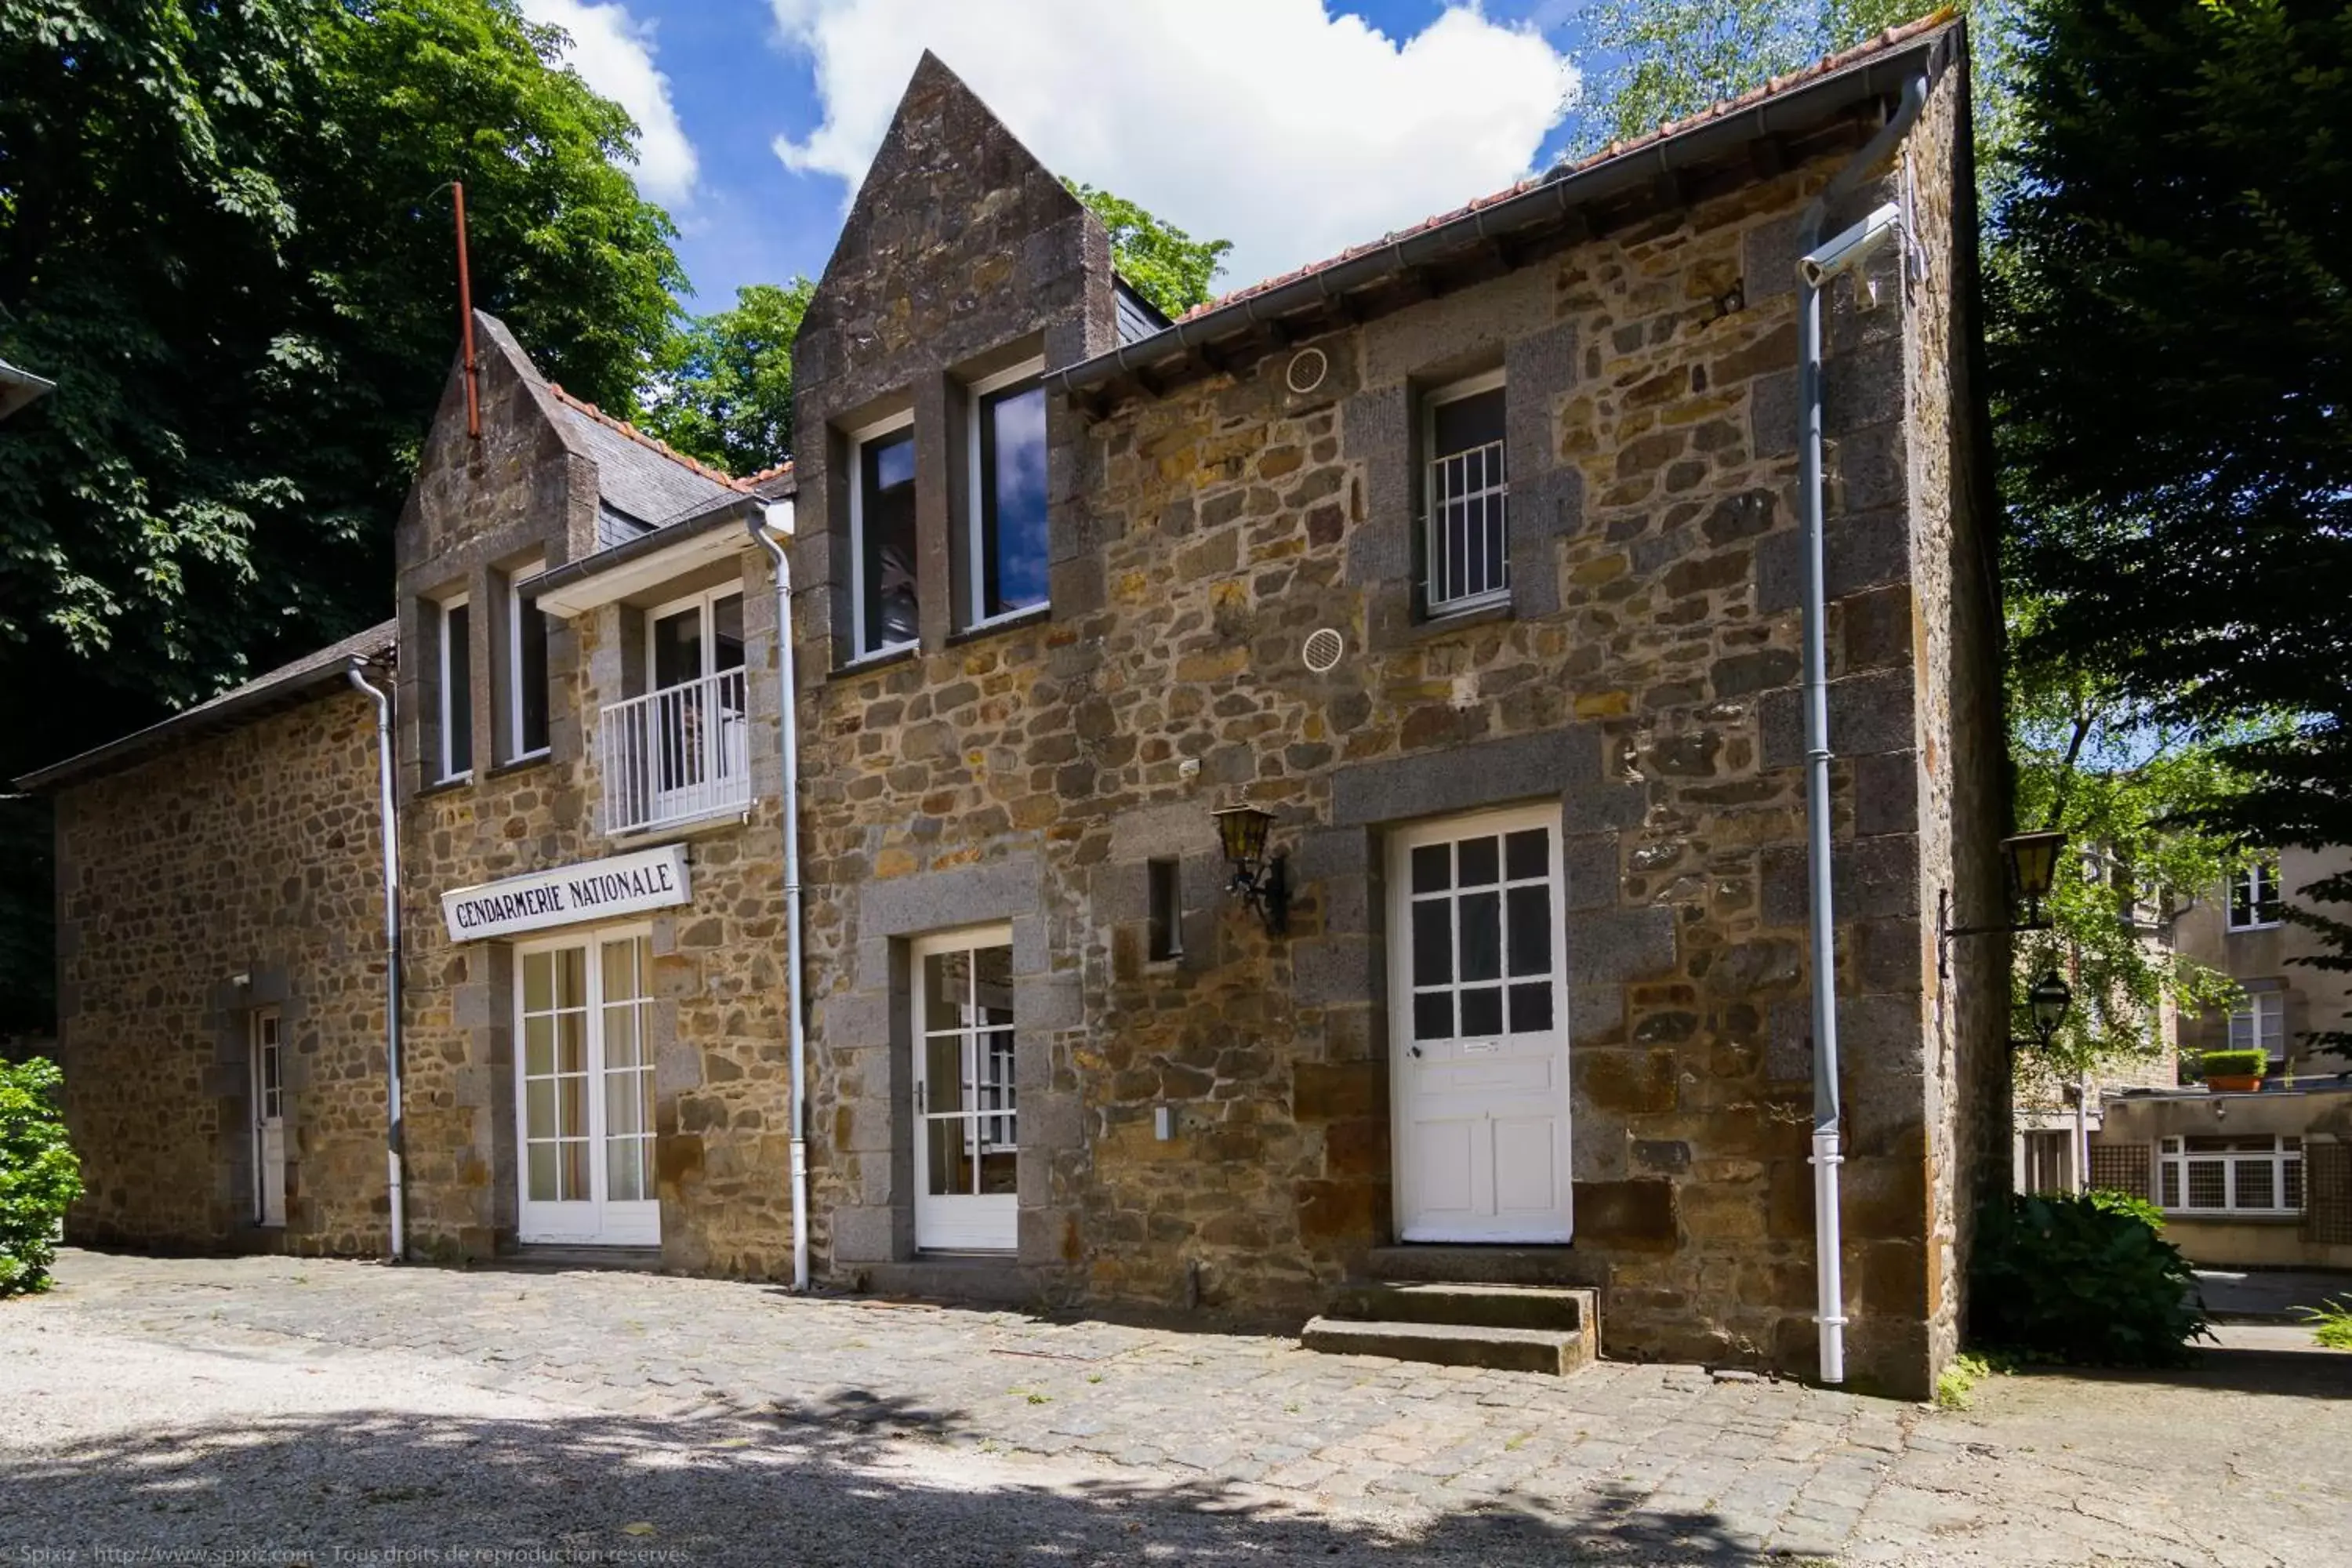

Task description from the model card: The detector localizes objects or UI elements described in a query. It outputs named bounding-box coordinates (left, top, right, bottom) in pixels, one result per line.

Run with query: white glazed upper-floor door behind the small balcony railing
left=647, top=593, right=750, bottom=820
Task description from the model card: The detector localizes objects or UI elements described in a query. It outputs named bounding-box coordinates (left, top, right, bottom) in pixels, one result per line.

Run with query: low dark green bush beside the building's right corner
left=1969, top=1192, right=2206, bottom=1366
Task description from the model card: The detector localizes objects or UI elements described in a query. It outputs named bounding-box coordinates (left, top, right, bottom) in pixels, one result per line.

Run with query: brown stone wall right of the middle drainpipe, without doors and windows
left=795, top=55, right=1997, bottom=1392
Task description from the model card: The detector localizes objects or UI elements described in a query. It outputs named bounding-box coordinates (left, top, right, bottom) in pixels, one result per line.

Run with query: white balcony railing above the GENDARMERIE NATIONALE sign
left=597, top=670, right=750, bottom=834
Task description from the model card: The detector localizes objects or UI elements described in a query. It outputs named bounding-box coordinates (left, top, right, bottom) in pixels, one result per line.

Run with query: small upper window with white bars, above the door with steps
left=1421, top=372, right=1510, bottom=616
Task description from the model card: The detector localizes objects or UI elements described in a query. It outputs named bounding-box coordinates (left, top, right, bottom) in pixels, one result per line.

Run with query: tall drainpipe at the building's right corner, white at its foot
left=1797, top=75, right=1926, bottom=1382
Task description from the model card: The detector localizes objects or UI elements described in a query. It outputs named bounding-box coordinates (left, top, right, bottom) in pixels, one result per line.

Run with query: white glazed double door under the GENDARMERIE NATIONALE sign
left=515, top=933, right=661, bottom=1246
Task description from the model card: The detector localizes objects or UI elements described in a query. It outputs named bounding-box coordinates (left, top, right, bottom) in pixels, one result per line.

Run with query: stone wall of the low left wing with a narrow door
left=56, top=691, right=388, bottom=1253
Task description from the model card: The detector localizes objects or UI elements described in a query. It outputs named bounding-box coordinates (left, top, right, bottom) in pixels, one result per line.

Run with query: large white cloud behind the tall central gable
left=771, top=0, right=1578, bottom=289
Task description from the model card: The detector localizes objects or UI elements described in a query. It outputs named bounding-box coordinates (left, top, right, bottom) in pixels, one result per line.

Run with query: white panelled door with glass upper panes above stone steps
left=1388, top=804, right=1569, bottom=1241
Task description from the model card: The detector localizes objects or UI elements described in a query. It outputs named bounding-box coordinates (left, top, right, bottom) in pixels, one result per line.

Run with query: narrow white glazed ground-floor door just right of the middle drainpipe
left=913, top=926, right=1021, bottom=1250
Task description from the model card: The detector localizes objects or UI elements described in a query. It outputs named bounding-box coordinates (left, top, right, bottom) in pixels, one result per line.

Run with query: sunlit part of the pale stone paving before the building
left=0, top=1253, right=2352, bottom=1568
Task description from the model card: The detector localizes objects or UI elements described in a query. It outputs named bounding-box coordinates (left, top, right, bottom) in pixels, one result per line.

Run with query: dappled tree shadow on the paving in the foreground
left=0, top=1389, right=1766, bottom=1568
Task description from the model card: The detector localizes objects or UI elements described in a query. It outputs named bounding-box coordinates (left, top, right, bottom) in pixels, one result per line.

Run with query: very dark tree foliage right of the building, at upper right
left=1990, top=0, right=2352, bottom=1046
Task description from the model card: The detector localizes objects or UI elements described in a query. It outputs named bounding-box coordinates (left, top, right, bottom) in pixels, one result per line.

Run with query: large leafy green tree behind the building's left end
left=0, top=0, right=682, bottom=1029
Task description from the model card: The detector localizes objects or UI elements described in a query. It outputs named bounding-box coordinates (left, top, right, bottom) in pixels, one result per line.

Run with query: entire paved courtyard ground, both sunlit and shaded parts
left=0, top=1253, right=2352, bottom=1568
